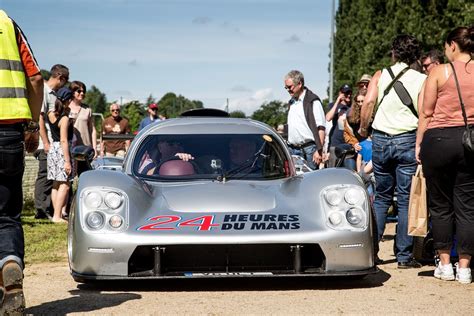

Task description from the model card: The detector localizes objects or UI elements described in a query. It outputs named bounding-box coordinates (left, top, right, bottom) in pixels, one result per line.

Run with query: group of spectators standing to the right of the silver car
left=284, top=26, right=474, bottom=283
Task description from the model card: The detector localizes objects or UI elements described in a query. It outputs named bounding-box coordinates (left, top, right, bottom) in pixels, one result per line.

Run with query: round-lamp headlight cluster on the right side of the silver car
left=321, top=184, right=369, bottom=230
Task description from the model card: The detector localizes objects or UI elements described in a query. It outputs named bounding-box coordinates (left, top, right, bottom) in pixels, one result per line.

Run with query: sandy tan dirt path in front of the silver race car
left=24, top=224, right=474, bottom=315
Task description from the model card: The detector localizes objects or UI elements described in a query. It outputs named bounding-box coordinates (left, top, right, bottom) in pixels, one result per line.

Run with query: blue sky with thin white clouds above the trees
left=0, top=0, right=331, bottom=115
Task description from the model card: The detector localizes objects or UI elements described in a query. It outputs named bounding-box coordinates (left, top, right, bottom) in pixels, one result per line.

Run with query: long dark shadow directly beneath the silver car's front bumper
left=78, top=270, right=391, bottom=293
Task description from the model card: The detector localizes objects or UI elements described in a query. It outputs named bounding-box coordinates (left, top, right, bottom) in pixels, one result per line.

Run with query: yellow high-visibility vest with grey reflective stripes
left=0, top=10, right=31, bottom=120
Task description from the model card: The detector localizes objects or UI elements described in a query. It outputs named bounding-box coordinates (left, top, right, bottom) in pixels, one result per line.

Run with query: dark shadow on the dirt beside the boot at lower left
left=25, top=290, right=142, bottom=315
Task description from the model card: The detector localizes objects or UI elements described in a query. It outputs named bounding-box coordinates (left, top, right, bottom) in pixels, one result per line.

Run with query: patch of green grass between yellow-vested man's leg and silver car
left=21, top=200, right=67, bottom=264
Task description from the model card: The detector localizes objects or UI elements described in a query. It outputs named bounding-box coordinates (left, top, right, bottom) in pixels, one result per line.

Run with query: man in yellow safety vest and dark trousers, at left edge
left=0, top=10, right=43, bottom=315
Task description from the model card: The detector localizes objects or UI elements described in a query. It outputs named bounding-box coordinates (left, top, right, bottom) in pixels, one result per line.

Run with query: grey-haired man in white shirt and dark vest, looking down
left=285, top=70, right=326, bottom=170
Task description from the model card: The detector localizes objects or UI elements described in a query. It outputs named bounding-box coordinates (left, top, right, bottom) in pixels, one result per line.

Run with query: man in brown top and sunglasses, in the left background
left=100, top=103, right=130, bottom=158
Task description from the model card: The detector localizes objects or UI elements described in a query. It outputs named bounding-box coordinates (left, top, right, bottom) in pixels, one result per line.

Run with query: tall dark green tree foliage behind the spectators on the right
left=334, top=0, right=474, bottom=99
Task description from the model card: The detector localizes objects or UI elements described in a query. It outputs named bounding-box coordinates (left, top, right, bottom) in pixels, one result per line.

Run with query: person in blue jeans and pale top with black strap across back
left=359, top=35, right=426, bottom=269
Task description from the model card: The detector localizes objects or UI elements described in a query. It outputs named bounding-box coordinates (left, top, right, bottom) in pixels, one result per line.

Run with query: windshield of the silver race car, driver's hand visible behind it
left=133, top=134, right=288, bottom=181
